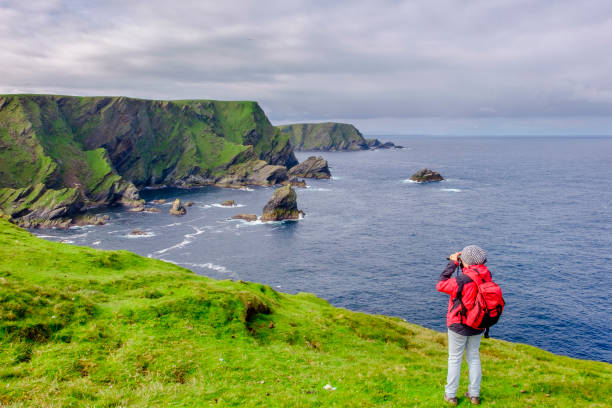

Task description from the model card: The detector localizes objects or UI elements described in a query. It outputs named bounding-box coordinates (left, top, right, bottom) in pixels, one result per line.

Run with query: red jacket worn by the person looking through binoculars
left=436, top=261, right=491, bottom=336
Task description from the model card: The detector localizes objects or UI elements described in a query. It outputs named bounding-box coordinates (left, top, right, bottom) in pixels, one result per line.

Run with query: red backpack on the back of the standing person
left=457, top=268, right=506, bottom=338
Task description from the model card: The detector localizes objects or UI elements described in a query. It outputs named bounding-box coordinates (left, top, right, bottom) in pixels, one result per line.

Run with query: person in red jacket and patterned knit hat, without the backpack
left=436, top=245, right=491, bottom=405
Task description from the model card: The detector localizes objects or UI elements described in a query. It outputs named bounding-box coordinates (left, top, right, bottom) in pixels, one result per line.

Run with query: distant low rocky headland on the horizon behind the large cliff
left=277, top=122, right=402, bottom=152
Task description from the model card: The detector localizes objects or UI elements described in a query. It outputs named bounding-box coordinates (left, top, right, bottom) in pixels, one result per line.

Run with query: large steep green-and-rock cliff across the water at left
left=0, top=95, right=297, bottom=225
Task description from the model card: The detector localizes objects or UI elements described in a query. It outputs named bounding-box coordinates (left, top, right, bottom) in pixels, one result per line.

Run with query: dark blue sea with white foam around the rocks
left=36, top=136, right=612, bottom=362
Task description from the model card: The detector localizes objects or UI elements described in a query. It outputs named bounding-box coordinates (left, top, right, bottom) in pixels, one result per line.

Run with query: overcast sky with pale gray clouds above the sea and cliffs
left=0, top=0, right=612, bottom=135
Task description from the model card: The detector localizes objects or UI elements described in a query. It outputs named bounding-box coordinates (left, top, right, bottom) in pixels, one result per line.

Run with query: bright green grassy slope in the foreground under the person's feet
left=0, top=219, right=612, bottom=408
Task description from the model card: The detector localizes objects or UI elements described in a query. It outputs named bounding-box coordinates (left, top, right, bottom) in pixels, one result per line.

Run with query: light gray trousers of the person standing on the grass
left=444, top=330, right=482, bottom=397
